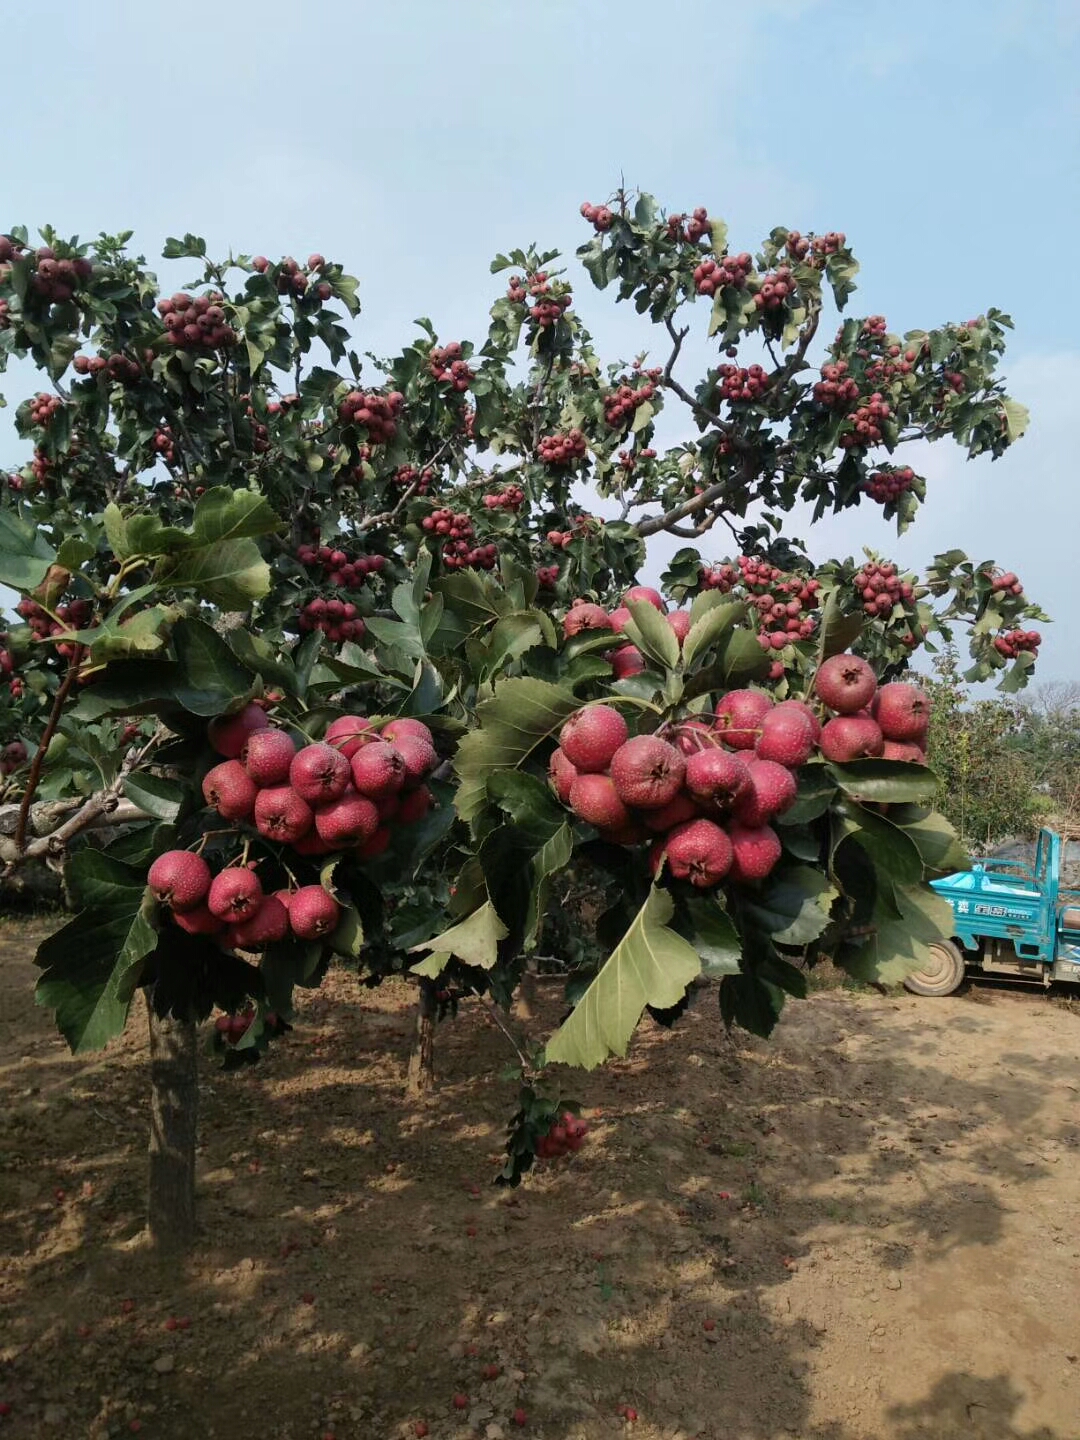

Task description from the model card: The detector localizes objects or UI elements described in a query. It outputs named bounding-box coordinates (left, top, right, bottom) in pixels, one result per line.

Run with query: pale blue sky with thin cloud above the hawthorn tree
left=0, top=0, right=1080, bottom=680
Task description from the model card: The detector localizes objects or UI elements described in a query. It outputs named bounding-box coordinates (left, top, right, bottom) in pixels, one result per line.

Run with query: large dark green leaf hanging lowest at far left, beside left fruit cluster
left=35, top=850, right=157, bottom=1053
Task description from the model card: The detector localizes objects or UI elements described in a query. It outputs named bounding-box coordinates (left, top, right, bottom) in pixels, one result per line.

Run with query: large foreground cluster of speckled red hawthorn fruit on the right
left=549, top=639, right=930, bottom=888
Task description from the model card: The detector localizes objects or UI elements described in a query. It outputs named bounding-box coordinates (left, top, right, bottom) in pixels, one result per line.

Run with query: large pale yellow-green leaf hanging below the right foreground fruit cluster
left=544, top=886, right=701, bottom=1070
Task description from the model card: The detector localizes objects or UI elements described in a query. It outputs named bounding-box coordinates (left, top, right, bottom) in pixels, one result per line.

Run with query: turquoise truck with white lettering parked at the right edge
left=904, top=829, right=1080, bottom=995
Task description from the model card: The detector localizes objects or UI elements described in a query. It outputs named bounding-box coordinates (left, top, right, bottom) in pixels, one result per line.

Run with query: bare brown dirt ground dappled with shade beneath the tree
left=0, top=923, right=1080, bottom=1440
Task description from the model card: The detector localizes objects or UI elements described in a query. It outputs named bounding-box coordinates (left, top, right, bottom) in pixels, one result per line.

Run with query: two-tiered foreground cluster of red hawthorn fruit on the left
left=147, top=704, right=438, bottom=950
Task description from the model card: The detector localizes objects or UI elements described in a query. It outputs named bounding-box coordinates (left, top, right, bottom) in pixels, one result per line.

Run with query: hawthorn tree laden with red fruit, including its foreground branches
left=0, top=192, right=1040, bottom=1246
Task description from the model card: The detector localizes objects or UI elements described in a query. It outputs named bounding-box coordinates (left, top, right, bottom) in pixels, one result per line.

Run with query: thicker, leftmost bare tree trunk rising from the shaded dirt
left=147, top=1004, right=199, bottom=1254
